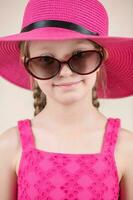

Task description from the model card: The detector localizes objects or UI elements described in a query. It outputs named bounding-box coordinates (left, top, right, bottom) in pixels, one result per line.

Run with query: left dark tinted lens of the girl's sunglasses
left=28, top=56, right=59, bottom=78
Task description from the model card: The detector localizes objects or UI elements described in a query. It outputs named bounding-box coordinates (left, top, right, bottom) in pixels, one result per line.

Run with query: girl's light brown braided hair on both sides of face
left=19, top=40, right=107, bottom=116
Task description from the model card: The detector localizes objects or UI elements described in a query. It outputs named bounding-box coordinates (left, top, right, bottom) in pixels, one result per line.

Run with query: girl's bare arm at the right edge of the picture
left=120, top=129, right=133, bottom=200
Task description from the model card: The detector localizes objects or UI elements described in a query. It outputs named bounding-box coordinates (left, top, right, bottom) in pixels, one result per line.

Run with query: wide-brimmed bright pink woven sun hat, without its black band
left=0, top=0, right=133, bottom=98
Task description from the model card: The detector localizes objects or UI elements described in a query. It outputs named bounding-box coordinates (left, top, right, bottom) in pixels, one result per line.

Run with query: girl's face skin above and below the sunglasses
left=29, top=40, right=98, bottom=104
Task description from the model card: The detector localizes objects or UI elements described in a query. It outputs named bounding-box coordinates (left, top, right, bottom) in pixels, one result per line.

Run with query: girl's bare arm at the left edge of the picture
left=0, top=127, right=18, bottom=200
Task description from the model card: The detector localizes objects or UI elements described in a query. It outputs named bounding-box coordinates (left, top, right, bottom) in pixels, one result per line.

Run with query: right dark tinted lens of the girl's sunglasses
left=70, top=51, right=101, bottom=74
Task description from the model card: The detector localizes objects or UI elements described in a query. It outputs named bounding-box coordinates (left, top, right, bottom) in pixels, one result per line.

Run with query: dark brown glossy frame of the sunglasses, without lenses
left=24, top=47, right=104, bottom=80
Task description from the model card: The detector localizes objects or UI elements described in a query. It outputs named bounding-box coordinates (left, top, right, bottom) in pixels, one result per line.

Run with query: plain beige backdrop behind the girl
left=0, top=0, right=133, bottom=133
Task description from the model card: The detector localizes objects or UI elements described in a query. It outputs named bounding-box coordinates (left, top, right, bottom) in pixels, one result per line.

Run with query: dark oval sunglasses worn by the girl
left=24, top=48, right=104, bottom=80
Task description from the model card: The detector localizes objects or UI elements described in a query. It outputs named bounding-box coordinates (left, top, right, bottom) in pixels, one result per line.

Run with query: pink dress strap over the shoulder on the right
left=103, top=118, right=121, bottom=154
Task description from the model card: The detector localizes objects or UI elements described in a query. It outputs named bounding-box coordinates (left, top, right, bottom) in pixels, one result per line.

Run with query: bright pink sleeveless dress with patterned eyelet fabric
left=18, top=118, right=120, bottom=200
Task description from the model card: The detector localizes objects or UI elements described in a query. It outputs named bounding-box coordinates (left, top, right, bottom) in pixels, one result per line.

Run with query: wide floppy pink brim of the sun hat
left=0, top=27, right=133, bottom=98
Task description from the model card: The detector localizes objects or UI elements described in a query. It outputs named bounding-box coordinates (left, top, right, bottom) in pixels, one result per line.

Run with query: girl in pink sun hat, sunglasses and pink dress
left=0, top=0, right=133, bottom=200
